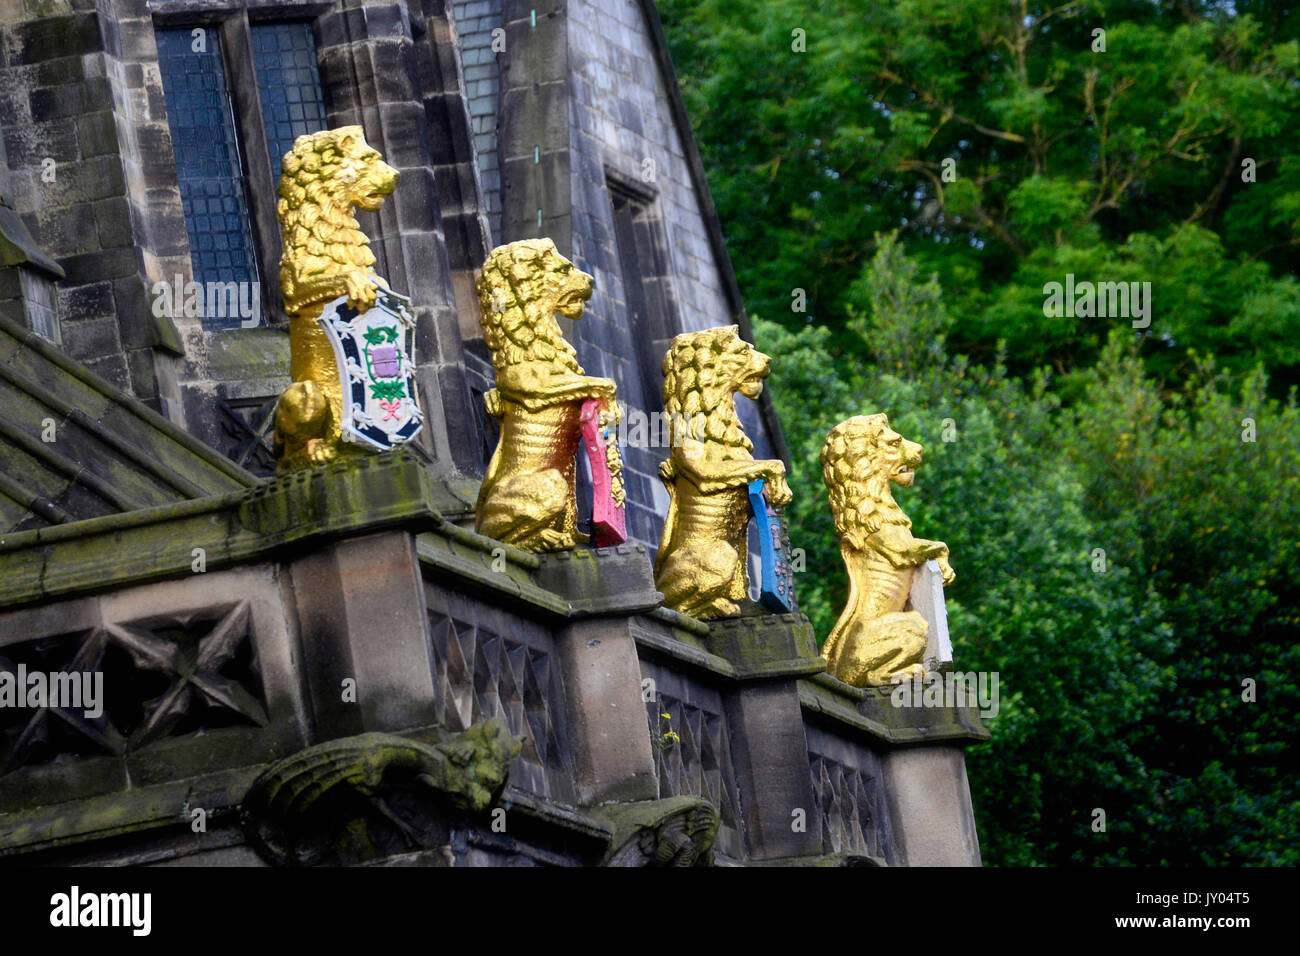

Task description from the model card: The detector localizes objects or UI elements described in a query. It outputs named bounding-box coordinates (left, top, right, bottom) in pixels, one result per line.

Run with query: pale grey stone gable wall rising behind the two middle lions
left=567, top=0, right=770, bottom=554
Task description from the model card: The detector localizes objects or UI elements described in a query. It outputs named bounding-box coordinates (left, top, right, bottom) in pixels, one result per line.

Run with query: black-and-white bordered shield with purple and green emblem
left=319, top=284, right=424, bottom=451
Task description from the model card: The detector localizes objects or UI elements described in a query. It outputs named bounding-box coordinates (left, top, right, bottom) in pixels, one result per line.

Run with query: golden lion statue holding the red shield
left=476, top=239, right=624, bottom=551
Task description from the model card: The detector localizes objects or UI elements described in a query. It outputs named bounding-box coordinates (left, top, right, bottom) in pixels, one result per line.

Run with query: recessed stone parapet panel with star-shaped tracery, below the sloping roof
left=0, top=568, right=304, bottom=810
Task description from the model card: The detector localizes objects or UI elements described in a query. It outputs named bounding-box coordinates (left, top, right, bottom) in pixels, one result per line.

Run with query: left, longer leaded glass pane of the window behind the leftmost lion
left=157, top=27, right=257, bottom=329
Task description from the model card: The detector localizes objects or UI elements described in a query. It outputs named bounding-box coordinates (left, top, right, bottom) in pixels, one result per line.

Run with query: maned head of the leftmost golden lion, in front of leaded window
left=276, top=126, right=398, bottom=312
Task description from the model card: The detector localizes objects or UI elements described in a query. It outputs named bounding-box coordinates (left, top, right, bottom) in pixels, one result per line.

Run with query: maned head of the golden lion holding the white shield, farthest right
left=822, top=412, right=922, bottom=549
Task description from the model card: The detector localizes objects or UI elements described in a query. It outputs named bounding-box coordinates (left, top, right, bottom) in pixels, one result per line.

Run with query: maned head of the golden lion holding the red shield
left=477, top=239, right=594, bottom=375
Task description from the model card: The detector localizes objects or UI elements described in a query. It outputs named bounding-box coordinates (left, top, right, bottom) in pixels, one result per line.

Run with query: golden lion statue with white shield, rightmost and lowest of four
left=822, top=415, right=956, bottom=687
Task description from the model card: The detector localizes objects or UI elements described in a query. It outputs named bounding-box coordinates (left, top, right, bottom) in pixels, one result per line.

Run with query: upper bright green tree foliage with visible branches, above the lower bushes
left=660, top=0, right=1300, bottom=394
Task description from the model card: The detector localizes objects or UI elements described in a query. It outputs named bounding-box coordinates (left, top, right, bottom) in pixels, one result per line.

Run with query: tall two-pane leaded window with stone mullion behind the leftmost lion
left=153, top=0, right=326, bottom=332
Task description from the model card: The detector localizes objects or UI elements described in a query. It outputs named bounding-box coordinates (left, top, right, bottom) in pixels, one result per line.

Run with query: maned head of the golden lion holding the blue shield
left=663, top=325, right=772, bottom=458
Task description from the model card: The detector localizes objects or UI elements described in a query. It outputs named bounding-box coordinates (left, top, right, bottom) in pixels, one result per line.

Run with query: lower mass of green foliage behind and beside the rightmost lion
left=755, top=235, right=1300, bottom=865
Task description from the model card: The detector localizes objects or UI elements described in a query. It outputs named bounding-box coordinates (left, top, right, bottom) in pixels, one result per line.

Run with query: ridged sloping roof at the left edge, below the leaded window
left=0, top=317, right=259, bottom=535
